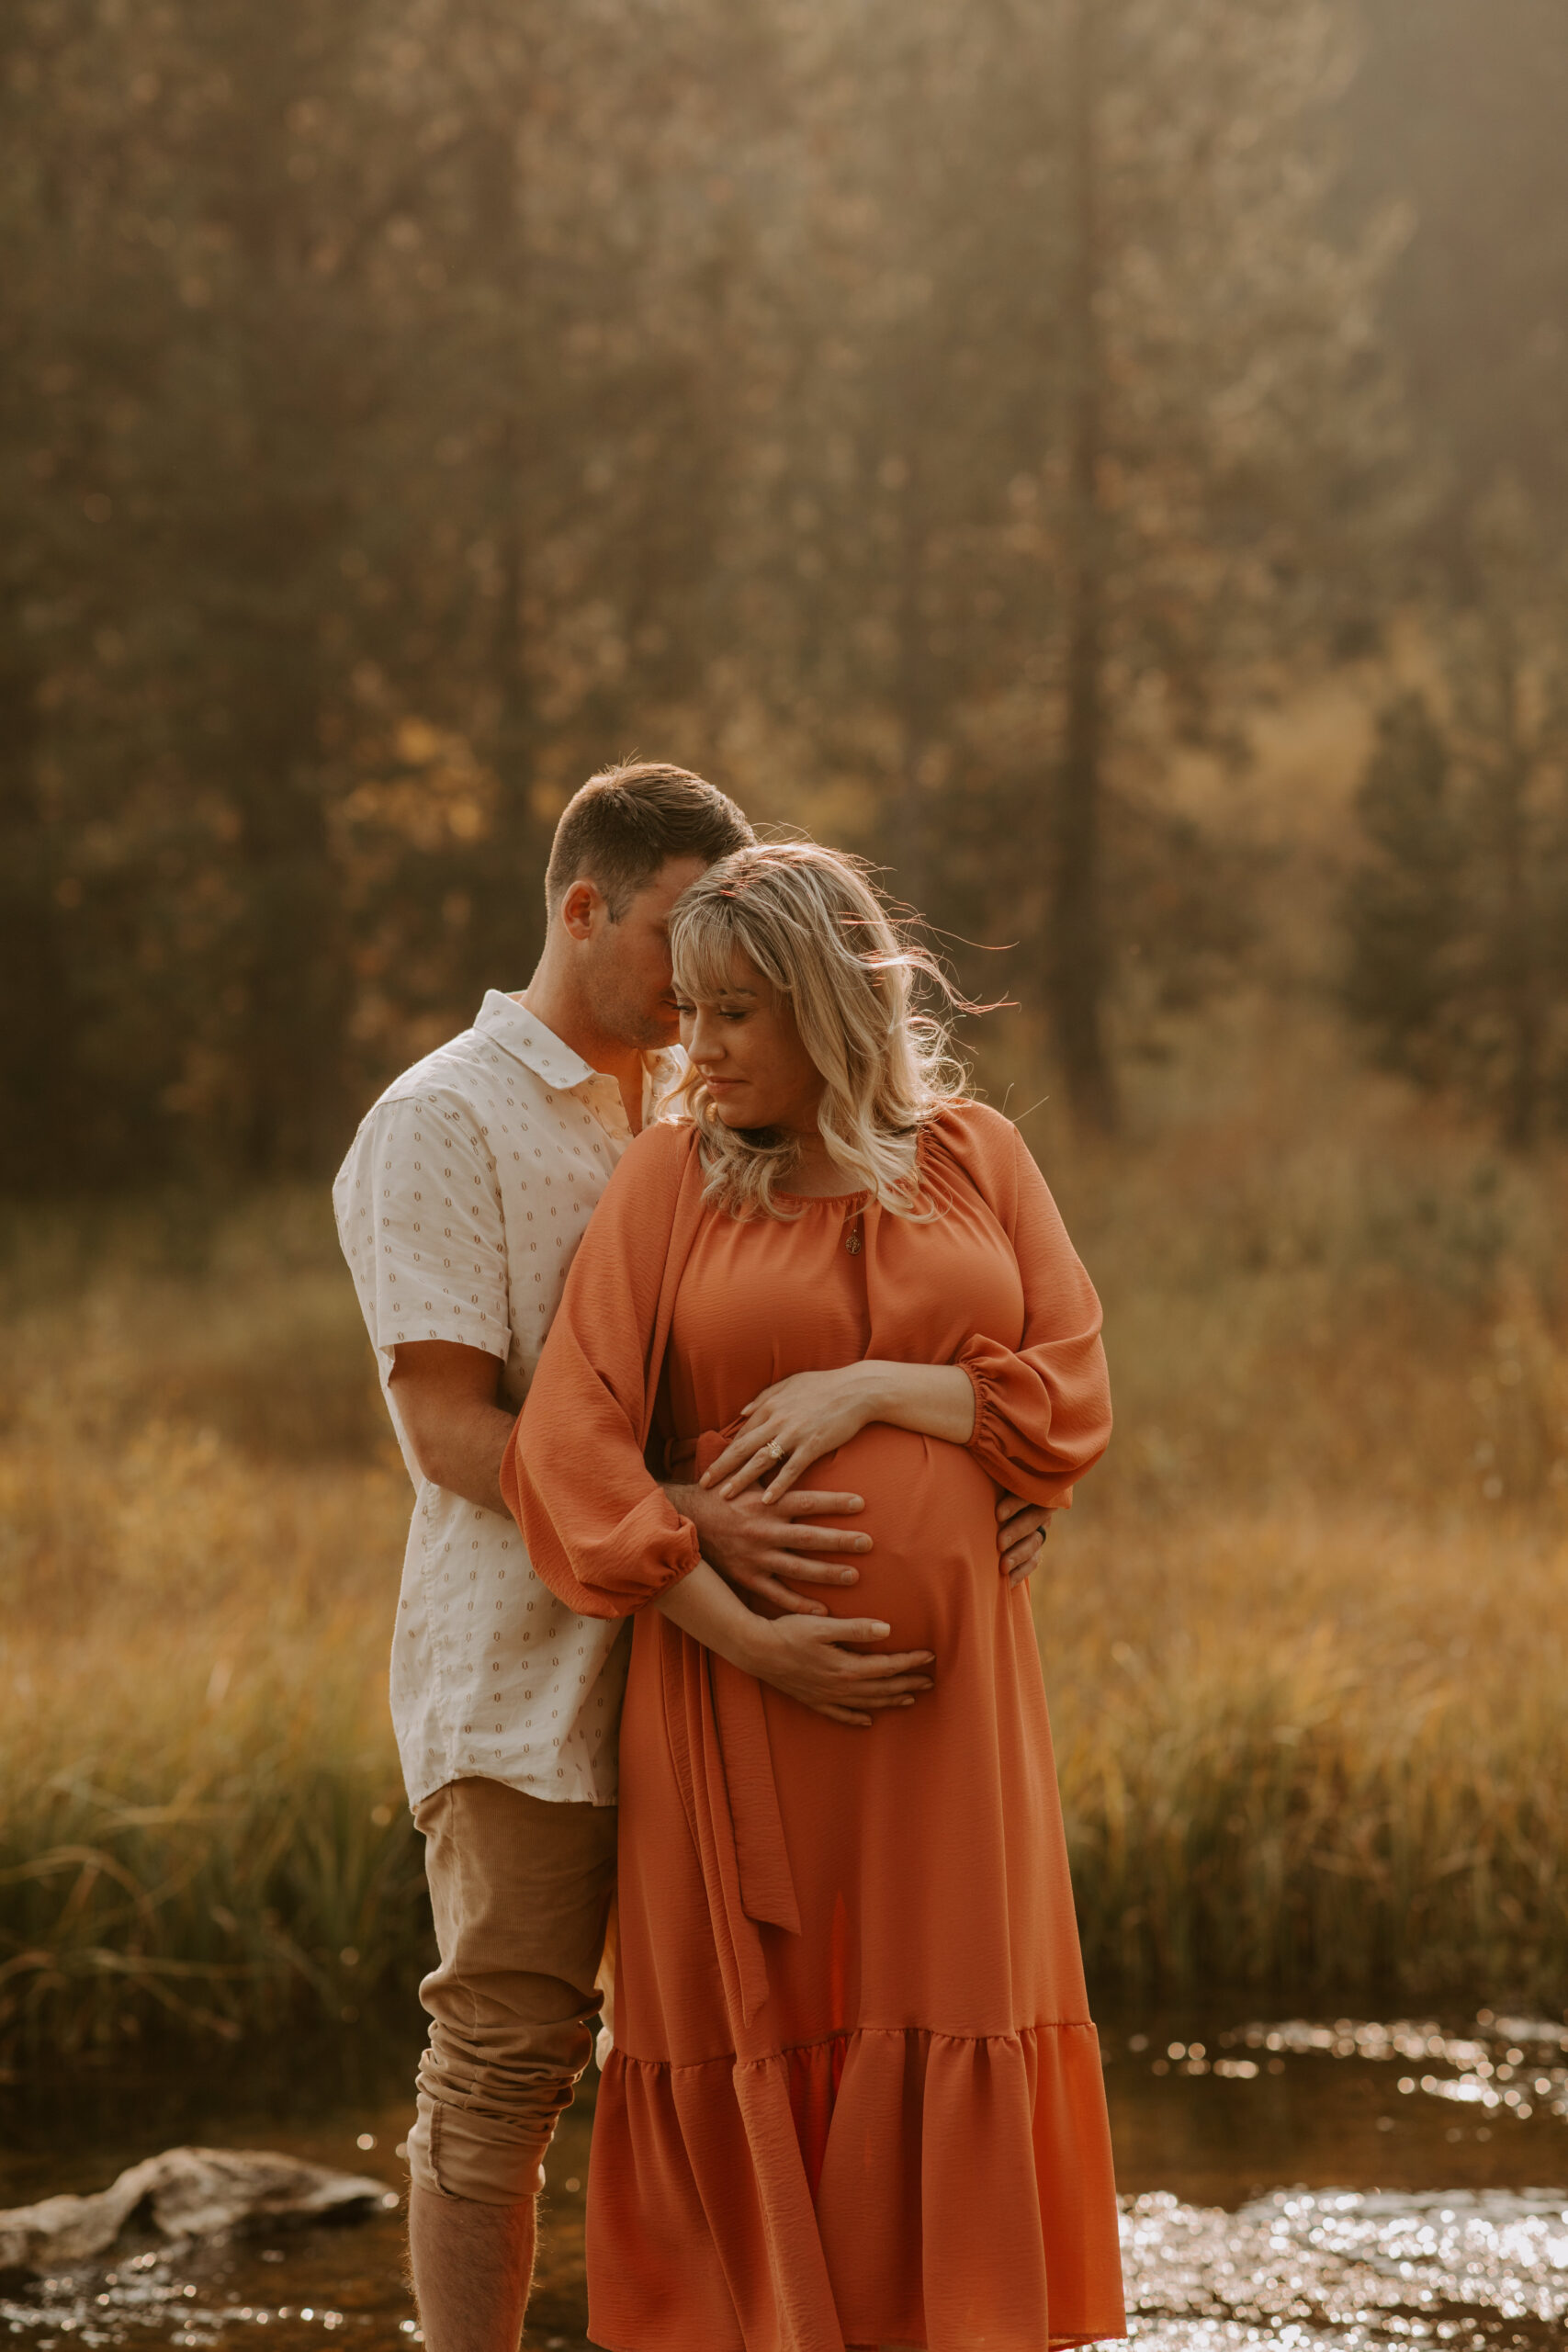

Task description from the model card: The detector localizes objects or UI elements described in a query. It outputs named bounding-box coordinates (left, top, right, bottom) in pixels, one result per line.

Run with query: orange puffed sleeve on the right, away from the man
left=957, top=1113, right=1110, bottom=1505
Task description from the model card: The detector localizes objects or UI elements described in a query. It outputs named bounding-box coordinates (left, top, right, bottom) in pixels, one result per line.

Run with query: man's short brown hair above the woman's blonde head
left=546, top=760, right=755, bottom=922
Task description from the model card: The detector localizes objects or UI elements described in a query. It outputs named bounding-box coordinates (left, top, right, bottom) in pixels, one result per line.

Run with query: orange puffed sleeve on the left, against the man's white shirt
left=501, top=1126, right=698, bottom=1618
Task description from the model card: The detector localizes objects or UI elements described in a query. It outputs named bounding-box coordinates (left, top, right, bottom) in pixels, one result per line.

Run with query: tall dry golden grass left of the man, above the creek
left=0, top=1197, right=428, bottom=2055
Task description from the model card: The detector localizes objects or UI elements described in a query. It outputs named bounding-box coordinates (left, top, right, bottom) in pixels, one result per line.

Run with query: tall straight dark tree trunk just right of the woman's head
left=1043, top=0, right=1117, bottom=1134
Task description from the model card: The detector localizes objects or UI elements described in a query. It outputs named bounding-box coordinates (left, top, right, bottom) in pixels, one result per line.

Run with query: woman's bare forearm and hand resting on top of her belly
left=701, top=1357, right=976, bottom=1503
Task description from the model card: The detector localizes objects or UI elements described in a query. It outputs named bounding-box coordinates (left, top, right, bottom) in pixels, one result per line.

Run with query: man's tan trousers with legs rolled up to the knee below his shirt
left=409, top=1781, right=616, bottom=2206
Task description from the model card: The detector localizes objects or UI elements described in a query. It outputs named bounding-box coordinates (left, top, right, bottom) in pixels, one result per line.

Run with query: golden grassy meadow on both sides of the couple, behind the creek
left=0, top=1004, right=1568, bottom=2065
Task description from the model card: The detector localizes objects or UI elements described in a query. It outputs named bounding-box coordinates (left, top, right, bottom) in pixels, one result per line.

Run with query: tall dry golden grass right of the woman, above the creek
left=1037, top=1007, right=1568, bottom=2007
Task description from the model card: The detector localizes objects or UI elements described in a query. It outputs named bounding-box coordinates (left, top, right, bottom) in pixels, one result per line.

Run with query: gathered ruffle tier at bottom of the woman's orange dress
left=588, top=2025, right=1126, bottom=2352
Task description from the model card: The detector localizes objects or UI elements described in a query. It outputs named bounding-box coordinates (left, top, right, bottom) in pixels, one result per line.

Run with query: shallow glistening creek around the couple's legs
left=0, top=2002, right=1568, bottom=2352
